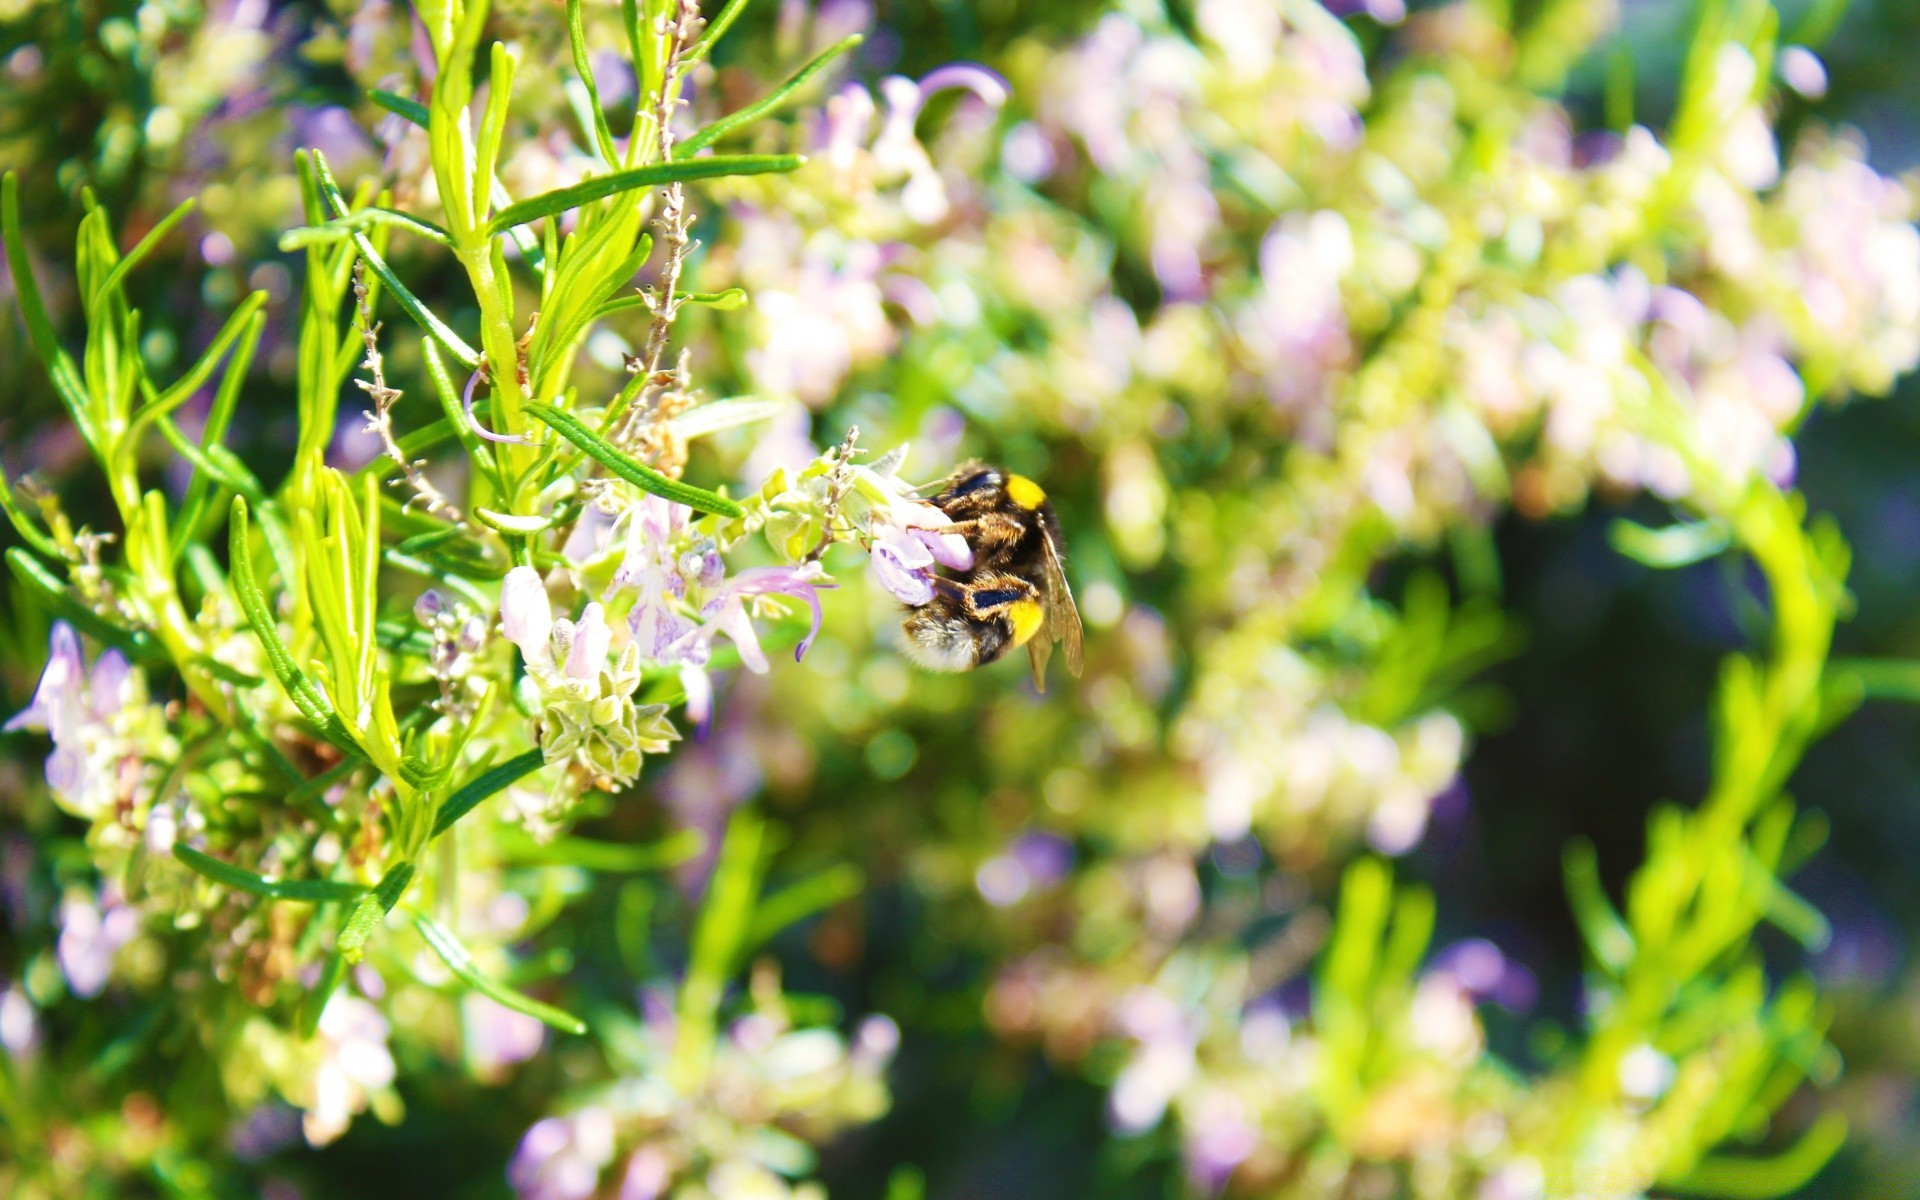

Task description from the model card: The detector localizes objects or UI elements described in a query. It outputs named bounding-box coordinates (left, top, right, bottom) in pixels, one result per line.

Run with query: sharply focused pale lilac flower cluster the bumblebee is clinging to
left=487, top=435, right=952, bottom=833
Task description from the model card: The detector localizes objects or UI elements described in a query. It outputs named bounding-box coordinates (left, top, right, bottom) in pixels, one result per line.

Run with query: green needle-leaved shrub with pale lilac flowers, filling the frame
left=0, top=0, right=1920, bottom=1200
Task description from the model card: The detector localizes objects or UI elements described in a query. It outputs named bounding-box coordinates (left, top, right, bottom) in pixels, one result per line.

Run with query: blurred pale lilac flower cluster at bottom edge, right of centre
left=987, top=940, right=1548, bottom=1200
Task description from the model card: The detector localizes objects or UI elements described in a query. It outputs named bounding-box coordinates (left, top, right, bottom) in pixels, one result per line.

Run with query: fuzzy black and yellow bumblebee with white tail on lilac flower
left=900, top=463, right=1083, bottom=691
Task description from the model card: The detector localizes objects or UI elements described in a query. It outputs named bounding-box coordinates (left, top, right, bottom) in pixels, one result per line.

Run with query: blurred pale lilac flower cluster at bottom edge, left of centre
left=507, top=977, right=900, bottom=1200
